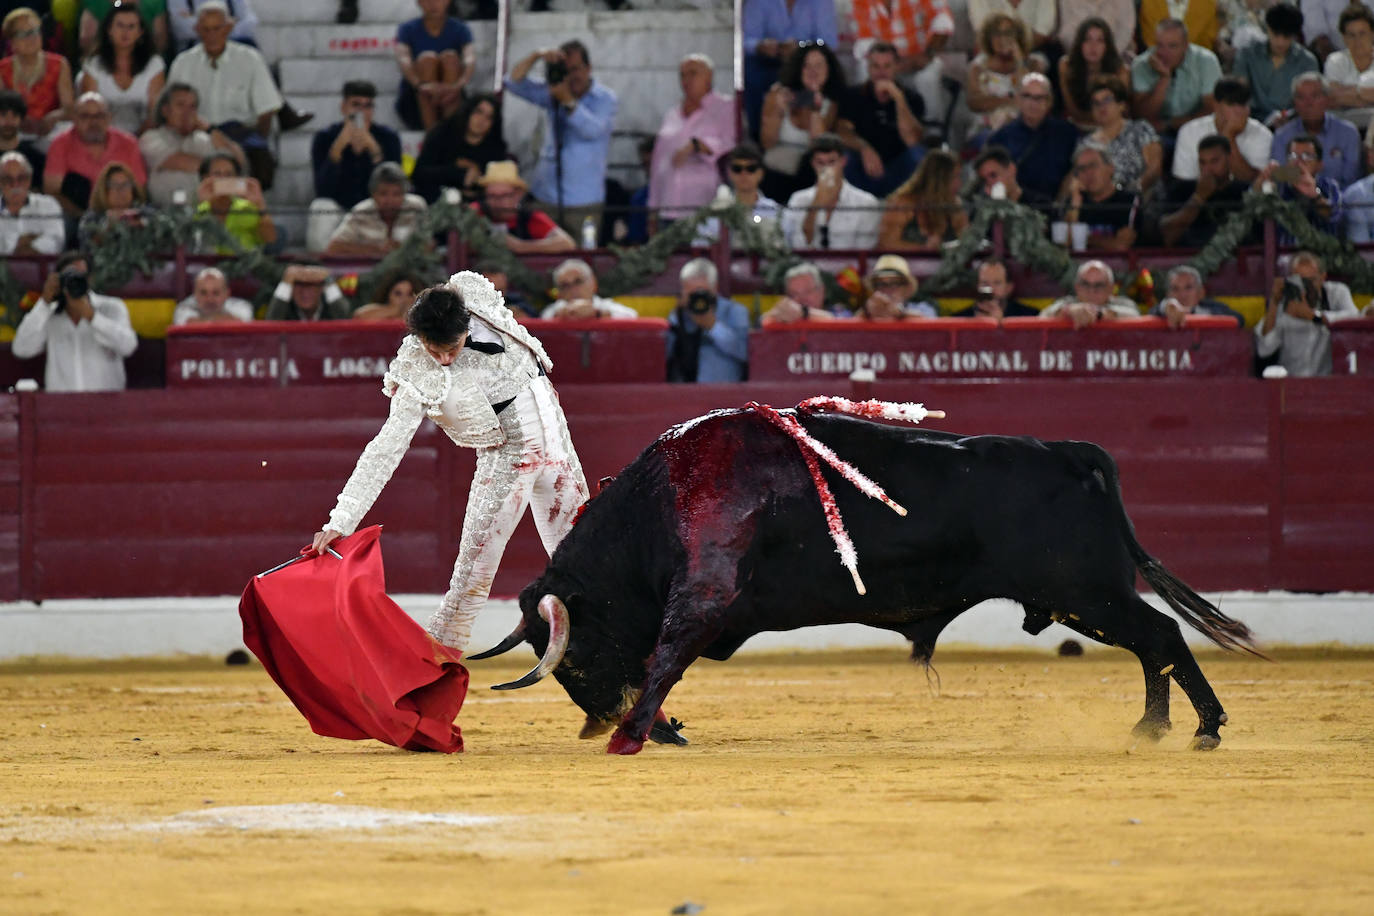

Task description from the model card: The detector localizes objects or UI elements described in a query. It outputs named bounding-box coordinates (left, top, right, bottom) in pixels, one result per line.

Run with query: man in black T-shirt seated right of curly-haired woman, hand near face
left=835, top=41, right=926, bottom=198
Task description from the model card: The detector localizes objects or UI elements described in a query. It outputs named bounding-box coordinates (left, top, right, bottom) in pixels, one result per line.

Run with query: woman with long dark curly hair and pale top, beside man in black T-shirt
left=758, top=44, right=845, bottom=201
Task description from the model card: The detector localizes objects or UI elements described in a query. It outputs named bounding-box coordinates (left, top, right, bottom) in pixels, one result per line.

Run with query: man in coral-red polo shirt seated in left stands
left=43, top=92, right=148, bottom=221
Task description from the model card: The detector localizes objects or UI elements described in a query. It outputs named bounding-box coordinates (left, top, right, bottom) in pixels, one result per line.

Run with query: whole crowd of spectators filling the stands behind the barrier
left=8, top=0, right=1374, bottom=387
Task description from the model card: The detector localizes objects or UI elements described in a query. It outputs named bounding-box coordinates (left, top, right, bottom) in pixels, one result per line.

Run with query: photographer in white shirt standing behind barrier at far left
left=10, top=251, right=139, bottom=391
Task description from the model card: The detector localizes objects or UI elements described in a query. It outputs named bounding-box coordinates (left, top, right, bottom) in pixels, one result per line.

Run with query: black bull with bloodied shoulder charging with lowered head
left=478, top=409, right=1257, bottom=754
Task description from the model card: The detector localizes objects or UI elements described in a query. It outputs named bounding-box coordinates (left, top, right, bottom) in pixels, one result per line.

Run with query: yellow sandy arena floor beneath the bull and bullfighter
left=0, top=650, right=1374, bottom=916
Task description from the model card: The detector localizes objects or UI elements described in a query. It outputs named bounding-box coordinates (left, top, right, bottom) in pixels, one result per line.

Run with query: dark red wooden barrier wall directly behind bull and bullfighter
left=0, top=378, right=1374, bottom=599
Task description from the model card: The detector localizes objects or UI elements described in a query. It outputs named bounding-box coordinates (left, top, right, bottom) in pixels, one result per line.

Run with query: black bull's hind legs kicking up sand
left=1059, top=593, right=1226, bottom=750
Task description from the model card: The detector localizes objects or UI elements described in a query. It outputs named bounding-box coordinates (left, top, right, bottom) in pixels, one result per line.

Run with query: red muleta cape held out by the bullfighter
left=239, top=525, right=467, bottom=754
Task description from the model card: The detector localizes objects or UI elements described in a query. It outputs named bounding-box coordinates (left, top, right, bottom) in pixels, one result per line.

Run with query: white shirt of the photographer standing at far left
left=10, top=293, right=139, bottom=391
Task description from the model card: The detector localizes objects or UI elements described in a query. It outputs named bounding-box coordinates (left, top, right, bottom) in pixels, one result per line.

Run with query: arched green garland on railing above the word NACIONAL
left=921, top=198, right=1074, bottom=293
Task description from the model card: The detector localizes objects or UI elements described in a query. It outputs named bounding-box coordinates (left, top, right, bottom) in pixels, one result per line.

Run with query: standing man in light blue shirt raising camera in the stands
left=506, top=41, right=620, bottom=239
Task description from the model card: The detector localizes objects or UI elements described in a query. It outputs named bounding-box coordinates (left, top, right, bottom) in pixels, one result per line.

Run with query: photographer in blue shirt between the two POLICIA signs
left=668, top=258, right=749, bottom=382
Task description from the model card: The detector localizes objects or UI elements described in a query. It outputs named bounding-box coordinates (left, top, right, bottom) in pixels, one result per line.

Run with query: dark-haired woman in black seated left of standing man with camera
left=411, top=92, right=510, bottom=203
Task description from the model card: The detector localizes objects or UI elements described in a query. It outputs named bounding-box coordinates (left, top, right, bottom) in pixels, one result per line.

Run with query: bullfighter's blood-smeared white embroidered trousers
left=426, top=376, right=588, bottom=651
